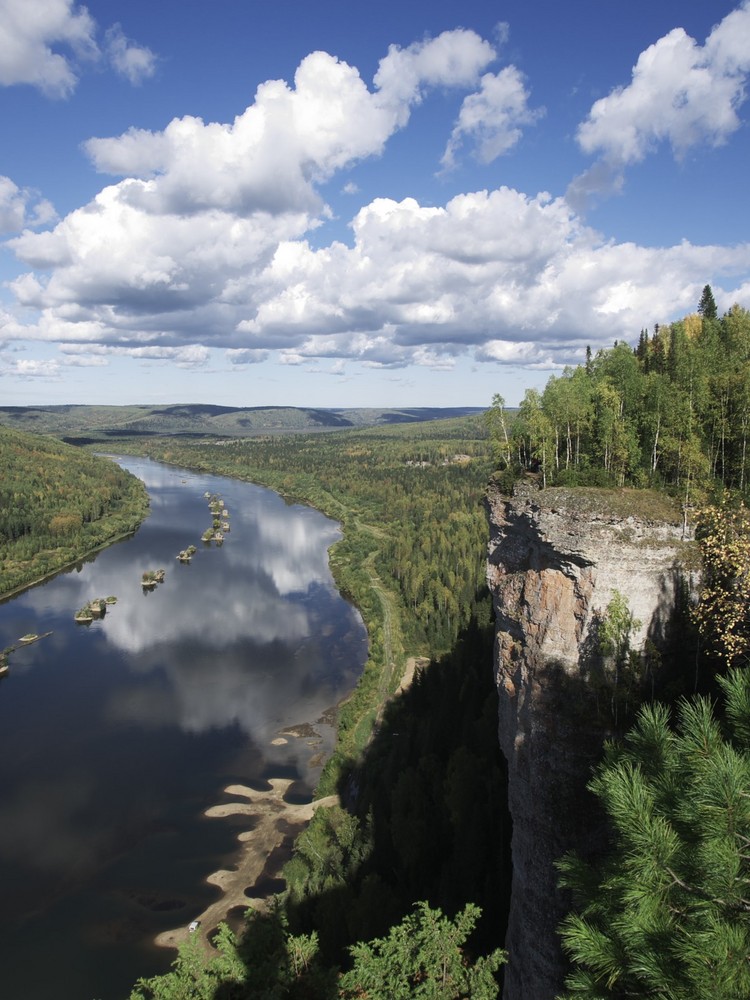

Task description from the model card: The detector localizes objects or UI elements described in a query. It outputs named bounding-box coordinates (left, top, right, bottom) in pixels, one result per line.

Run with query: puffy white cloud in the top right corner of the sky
left=570, top=0, right=750, bottom=204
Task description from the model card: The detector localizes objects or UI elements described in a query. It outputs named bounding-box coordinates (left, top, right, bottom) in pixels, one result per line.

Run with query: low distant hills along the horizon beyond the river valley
left=0, top=403, right=484, bottom=444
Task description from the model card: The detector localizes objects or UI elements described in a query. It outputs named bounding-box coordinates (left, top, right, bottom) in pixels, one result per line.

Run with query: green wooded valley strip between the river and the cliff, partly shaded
left=119, top=417, right=510, bottom=997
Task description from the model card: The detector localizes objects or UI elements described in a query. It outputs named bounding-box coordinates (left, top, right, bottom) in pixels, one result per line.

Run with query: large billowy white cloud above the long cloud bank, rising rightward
left=85, top=30, right=494, bottom=215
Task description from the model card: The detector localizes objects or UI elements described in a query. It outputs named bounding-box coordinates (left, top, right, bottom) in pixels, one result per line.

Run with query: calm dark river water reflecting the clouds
left=0, top=458, right=366, bottom=1000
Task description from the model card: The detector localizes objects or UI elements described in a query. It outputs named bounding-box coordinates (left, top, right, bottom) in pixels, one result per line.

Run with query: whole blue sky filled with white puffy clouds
left=0, top=0, right=750, bottom=407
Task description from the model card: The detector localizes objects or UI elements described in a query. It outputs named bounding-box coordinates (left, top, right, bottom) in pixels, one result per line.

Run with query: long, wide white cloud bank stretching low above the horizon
left=5, top=180, right=750, bottom=368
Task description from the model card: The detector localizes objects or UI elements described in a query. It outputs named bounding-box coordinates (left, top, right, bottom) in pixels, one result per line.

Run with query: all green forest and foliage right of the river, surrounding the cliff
left=1, top=286, right=750, bottom=1000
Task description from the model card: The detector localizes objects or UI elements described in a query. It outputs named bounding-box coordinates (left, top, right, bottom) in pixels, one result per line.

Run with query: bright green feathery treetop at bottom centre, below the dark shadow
left=339, top=903, right=505, bottom=1000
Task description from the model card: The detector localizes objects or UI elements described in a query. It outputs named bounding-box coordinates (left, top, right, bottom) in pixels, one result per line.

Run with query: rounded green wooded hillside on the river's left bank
left=0, top=429, right=148, bottom=595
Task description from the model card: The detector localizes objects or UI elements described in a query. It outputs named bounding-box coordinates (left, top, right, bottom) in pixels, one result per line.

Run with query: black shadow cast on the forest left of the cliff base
left=274, top=622, right=511, bottom=988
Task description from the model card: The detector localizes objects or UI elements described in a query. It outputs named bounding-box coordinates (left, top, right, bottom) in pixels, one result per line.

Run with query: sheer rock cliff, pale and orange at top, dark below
left=487, top=480, right=696, bottom=1000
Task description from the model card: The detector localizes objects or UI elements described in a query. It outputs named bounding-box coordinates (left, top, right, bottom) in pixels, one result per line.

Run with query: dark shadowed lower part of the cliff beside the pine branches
left=506, top=566, right=713, bottom=989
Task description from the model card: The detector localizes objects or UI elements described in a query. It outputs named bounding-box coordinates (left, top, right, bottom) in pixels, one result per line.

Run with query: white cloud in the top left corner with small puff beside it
left=0, top=0, right=155, bottom=98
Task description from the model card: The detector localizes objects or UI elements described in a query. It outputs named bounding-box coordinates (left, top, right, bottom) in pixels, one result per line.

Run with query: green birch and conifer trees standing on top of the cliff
left=500, top=285, right=750, bottom=503
